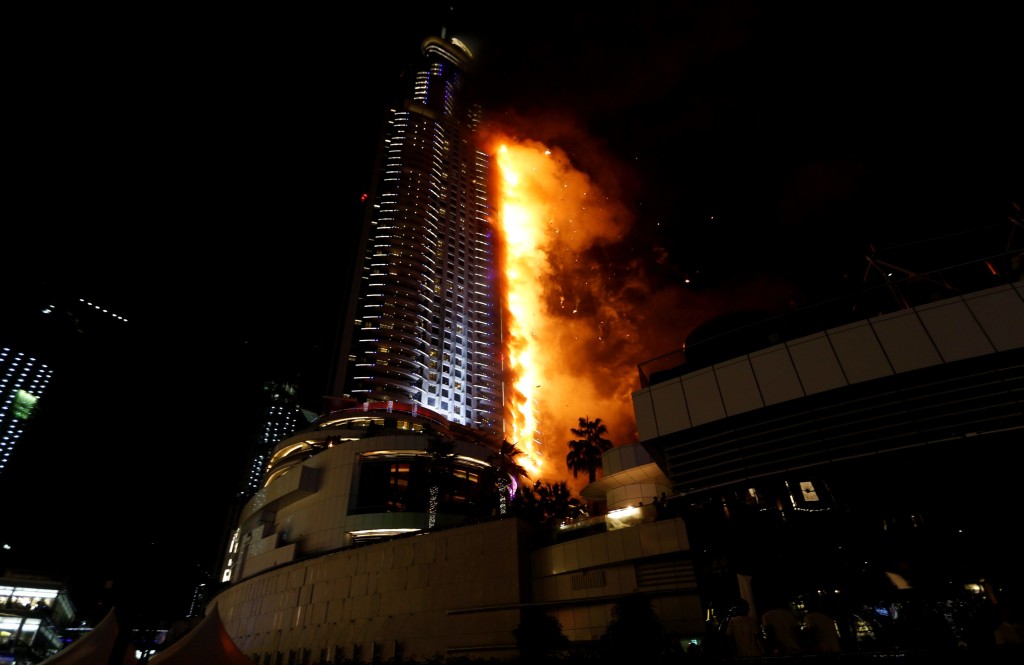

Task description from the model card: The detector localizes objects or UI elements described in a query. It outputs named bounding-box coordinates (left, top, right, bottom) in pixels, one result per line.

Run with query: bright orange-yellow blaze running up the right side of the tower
left=495, top=137, right=636, bottom=485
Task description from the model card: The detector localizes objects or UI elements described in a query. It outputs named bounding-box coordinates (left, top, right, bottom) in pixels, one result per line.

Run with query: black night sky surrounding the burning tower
left=0, top=1, right=1024, bottom=627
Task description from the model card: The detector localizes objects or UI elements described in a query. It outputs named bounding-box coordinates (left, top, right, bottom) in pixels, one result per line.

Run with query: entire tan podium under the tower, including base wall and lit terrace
left=209, top=403, right=702, bottom=665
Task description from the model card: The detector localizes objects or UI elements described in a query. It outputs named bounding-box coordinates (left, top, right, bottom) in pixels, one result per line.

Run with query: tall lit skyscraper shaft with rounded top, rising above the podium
left=334, top=32, right=503, bottom=435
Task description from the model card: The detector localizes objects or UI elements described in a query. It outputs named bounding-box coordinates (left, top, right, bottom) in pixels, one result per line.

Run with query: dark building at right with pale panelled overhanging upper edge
left=633, top=262, right=1024, bottom=649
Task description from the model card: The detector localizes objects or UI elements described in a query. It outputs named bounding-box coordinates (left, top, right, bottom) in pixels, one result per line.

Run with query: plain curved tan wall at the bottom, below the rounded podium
left=220, top=519, right=524, bottom=662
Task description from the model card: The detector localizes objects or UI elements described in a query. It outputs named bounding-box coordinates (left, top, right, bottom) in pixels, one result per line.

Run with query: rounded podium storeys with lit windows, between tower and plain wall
left=221, top=403, right=497, bottom=582
